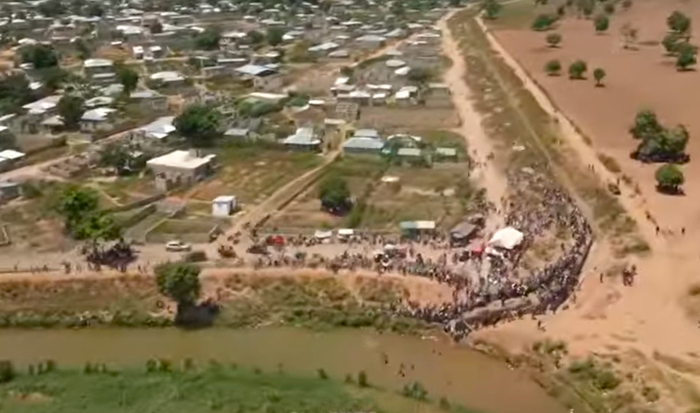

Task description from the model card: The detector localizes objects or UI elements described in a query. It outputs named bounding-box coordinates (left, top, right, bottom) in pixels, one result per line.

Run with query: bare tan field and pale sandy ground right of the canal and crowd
left=468, top=1, right=700, bottom=410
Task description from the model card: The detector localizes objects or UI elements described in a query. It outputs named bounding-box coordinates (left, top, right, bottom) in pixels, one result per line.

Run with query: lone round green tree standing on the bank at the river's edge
left=155, top=262, right=202, bottom=307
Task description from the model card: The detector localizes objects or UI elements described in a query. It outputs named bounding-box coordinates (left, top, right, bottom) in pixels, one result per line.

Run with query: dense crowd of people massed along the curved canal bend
left=401, top=169, right=593, bottom=339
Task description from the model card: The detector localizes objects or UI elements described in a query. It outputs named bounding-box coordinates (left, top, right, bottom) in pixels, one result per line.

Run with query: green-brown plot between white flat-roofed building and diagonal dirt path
left=184, top=146, right=321, bottom=205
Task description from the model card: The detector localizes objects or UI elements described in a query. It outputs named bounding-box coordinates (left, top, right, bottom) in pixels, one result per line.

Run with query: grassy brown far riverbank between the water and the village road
left=0, top=270, right=441, bottom=334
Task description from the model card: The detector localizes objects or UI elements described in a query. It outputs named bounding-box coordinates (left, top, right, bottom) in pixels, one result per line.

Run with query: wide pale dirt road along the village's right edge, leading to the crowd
left=437, top=12, right=508, bottom=229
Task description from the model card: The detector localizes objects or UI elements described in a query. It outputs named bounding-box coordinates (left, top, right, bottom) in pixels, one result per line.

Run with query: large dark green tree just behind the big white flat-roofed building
left=173, top=104, right=220, bottom=147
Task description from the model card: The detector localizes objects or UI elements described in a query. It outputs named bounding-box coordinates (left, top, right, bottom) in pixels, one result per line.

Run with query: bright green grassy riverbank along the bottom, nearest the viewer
left=0, top=359, right=476, bottom=413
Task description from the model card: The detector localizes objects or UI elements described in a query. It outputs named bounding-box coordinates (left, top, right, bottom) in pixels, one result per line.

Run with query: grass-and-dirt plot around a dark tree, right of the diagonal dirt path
left=268, top=140, right=477, bottom=232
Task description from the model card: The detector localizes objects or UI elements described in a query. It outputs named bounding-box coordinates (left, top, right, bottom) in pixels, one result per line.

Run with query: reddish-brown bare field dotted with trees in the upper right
left=490, top=0, right=700, bottom=226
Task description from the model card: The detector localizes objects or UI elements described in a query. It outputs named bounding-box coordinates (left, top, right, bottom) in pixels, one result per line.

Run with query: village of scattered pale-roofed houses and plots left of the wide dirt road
left=0, top=0, right=479, bottom=264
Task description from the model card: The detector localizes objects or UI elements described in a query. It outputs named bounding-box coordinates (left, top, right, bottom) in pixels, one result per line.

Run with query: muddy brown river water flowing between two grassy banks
left=0, top=328, right=566, bottom=413
